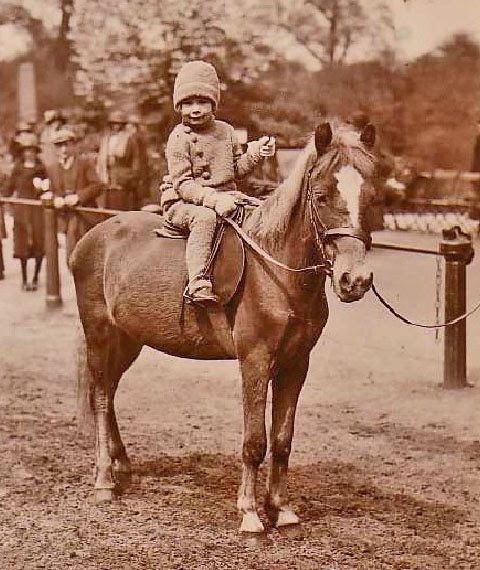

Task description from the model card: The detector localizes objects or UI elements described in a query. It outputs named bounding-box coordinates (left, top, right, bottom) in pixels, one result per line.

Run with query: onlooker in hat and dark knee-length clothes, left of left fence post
left=2, top=132, right=47, bottom=291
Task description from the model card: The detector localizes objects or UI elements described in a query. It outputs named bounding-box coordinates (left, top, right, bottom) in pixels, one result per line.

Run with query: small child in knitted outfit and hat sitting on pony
left=161, top=61, right=275, bottom=303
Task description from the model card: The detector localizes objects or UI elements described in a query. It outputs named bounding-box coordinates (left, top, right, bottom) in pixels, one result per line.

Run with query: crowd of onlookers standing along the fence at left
left=0, top=105, right=158, bottom=291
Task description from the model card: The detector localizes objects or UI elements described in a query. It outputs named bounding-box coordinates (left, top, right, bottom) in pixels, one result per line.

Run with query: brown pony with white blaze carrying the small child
left=71, top=123, right=375, bottom=533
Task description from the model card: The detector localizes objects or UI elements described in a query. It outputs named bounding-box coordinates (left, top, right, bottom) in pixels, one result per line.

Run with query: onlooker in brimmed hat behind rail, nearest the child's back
left=97, top=111, right=140, bottom=210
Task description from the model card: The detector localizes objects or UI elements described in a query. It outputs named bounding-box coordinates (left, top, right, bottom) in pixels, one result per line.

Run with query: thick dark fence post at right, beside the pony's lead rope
left=440, top=229, right=474, bottom=388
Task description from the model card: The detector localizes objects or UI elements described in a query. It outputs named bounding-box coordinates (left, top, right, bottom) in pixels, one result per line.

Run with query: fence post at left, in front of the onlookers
left=42, top=195, right=62, bottom=308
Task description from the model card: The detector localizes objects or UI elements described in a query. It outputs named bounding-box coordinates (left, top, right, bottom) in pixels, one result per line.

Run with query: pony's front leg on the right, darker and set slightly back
left=265, top=355, right=309, bottom=528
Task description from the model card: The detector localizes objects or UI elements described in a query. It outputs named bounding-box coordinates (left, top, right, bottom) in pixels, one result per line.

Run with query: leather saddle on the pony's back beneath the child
left=154, top=216, right=245, bottom=305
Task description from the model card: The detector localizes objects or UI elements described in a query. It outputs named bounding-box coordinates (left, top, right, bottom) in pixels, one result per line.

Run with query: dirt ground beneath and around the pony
left=0, top=215, right=480, bottom=570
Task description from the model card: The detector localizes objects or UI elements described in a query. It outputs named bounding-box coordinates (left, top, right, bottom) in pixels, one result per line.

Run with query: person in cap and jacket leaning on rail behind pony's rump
left=47, top=127, right=104, bottom=264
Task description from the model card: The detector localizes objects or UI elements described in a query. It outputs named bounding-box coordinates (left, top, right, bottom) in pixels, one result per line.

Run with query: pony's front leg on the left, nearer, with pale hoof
left=237, top=345, right=271, bottom=533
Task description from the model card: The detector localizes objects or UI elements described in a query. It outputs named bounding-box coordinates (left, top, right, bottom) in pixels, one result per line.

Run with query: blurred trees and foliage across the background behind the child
left=0, top=0, right=480, bottom=169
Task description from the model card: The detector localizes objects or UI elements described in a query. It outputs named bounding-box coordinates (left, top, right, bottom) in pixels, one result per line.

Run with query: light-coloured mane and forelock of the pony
left=245, top=124, right=375, bottom=247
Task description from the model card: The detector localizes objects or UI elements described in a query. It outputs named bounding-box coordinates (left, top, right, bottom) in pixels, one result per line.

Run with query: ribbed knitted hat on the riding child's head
left=173, top=60, right=220, bottom=111
